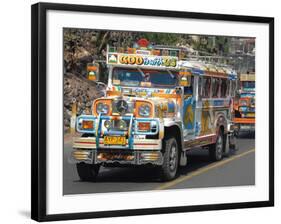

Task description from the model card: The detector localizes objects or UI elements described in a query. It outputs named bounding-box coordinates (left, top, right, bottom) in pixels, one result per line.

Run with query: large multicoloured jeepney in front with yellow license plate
left=72, top=44, right=237, bottom=181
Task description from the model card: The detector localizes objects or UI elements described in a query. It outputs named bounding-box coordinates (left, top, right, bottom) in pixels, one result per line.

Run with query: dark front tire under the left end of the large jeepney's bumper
left=76, top=163, right=100, bottom=181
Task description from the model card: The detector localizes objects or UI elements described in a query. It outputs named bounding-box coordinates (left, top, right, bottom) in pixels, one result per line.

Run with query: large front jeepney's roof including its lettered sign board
left=106, top=46, right=237, bottom=80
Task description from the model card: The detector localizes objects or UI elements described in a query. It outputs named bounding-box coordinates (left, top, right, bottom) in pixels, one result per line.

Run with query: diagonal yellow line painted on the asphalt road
left=154, top=149, right=255, bottom=190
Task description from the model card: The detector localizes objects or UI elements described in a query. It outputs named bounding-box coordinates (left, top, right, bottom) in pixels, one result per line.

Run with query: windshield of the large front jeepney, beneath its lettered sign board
left=112, top=68, right=178, bottom=88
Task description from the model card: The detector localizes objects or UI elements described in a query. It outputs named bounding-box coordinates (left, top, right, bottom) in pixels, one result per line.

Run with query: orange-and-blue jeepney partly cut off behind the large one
left=233, top=73, right=255, bottom=135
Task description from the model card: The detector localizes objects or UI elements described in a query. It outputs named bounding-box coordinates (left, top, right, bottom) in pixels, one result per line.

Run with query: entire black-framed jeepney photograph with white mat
left=31, top=3, right=274, bottom=221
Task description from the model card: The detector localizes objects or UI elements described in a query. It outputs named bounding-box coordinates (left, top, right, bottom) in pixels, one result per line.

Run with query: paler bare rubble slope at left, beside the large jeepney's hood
left=63, top=73, right=104, bottom=132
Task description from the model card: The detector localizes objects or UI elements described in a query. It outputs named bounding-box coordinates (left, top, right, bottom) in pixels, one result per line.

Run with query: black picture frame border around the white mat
left=31, top=3, right=274, bottom=221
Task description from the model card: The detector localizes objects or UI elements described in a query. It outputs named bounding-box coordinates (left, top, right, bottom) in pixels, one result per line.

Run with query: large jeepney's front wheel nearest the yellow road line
left=160, top=137, right=179, bottom=181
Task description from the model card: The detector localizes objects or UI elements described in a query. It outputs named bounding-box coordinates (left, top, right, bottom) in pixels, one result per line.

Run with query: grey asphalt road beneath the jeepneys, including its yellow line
left=63, top=136, right=255, bottom=195
